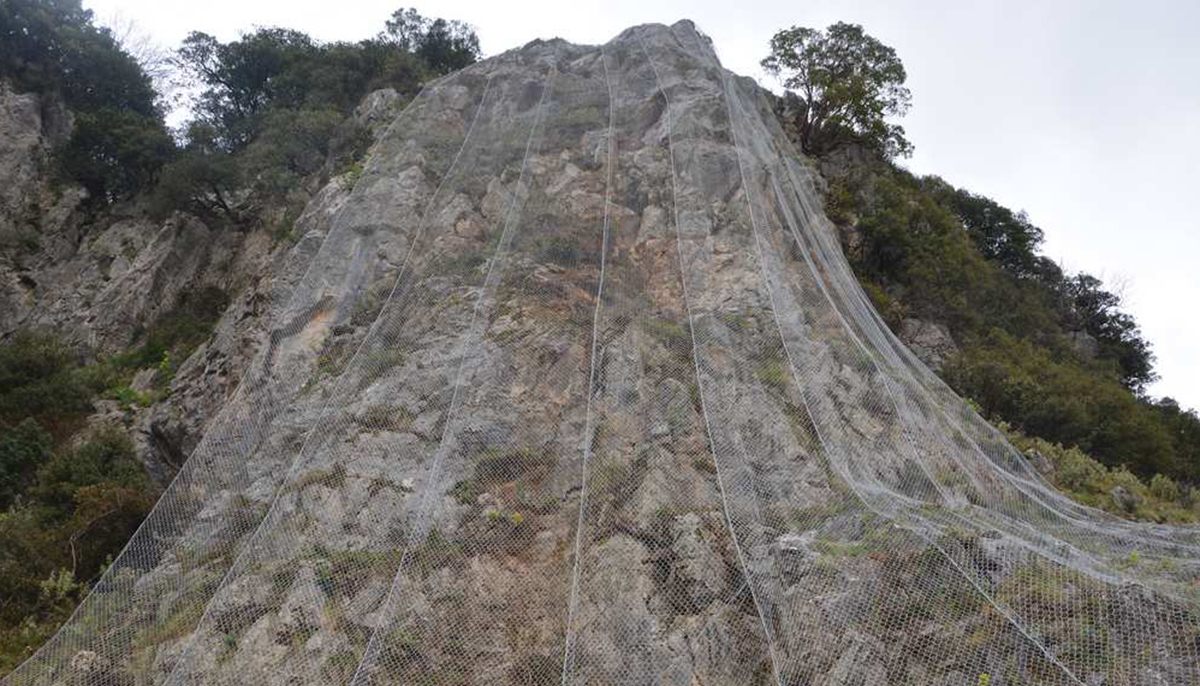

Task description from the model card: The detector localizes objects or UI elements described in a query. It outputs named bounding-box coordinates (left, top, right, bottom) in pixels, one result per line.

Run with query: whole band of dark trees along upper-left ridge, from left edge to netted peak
left=0, top=0, right=480, bottom=219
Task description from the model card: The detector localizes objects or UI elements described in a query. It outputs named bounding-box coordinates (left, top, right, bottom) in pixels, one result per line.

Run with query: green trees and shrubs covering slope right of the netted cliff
left=762, top=23, right=1200, bottom=503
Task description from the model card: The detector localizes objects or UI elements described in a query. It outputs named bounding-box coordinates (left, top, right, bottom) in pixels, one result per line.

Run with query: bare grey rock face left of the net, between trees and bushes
left=0, top=80, right=397, bottom=487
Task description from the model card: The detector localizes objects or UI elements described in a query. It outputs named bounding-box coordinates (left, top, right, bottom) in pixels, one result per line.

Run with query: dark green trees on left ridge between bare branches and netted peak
left=157, top=10, right=479, bottom=219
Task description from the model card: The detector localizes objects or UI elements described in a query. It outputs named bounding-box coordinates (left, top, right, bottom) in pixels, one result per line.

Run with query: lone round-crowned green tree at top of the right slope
left=762, top=22, right=912, bottom=157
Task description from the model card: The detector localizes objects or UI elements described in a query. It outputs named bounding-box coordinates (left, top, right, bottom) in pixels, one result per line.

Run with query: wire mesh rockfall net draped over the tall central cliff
left=4, top=22, right=1200, bottom=686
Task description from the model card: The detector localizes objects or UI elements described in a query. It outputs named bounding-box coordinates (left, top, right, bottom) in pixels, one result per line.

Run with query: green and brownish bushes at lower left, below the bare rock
left=0, top=288, right=227, bottom=674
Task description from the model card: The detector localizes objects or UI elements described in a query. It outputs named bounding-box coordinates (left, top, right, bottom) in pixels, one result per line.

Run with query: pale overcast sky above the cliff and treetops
left=84, top=0, right=1200, bottom=408
